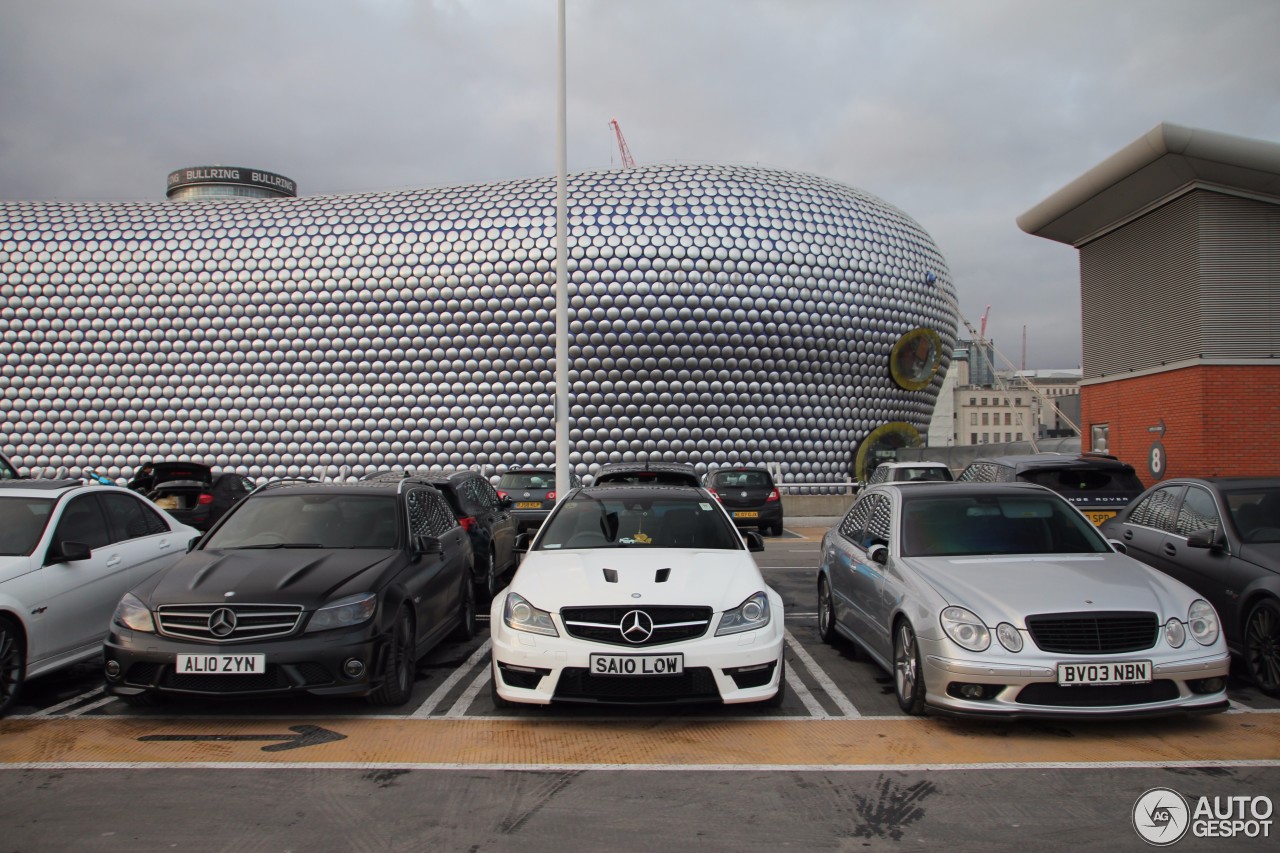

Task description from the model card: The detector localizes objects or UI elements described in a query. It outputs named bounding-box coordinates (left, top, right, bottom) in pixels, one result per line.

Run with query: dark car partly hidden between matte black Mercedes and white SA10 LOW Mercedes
left=393, top=469, right=520, bottom=603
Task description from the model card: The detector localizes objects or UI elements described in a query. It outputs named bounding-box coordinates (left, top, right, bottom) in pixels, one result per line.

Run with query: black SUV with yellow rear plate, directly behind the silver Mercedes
left=956, top=453, right=1143, bottom=524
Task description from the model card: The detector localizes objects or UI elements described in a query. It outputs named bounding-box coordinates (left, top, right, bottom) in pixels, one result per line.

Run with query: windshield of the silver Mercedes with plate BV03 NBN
left=901, top=494, right=1111, bottom=557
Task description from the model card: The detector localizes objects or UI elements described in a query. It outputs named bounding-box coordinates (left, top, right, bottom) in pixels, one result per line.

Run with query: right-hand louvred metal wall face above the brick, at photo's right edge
left=1199, top=192, right=1280, bottom=359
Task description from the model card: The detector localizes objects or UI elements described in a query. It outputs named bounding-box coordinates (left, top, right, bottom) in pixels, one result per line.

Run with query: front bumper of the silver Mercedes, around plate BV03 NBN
left=919, top=639, right=1231, bottom=720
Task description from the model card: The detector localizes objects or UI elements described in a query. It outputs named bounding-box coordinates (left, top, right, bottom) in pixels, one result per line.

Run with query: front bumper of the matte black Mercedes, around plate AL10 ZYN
left=102, top=624, right=388, bottom=698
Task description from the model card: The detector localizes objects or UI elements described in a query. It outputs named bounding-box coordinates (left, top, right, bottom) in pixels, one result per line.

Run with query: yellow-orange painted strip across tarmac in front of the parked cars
left=0, top=713, right=1280, bottom=767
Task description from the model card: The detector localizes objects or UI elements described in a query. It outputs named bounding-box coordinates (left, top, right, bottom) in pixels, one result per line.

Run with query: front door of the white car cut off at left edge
left=13, top=493, right=120, bottom=670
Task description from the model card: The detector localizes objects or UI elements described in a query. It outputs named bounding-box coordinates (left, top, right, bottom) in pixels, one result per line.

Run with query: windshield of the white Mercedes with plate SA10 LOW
left=536, top=496, right=742, bottom=551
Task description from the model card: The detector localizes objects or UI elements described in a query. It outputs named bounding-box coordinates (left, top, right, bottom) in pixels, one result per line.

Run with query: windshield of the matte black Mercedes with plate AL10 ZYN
left=204, top=493, right=397, bottom=549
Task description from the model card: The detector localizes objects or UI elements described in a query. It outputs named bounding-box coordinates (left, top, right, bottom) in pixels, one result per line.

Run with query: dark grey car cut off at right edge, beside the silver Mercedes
left=1102, top=476, right=1280, bottom=697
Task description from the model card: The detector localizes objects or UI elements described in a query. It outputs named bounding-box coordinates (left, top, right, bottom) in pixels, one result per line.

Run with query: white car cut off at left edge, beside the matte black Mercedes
left=0, top=480, right=200, bottom=715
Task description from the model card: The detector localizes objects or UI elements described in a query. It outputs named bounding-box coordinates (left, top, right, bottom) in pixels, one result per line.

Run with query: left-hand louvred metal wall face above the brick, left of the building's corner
left=1080, top=192, right=1203, bottom=379
